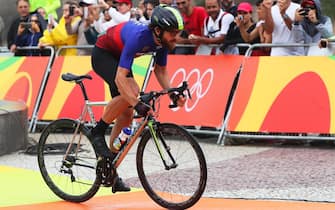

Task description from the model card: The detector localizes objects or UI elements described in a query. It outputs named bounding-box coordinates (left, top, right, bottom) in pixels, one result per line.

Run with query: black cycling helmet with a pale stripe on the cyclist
left=151, top=5, right=184, bottom=31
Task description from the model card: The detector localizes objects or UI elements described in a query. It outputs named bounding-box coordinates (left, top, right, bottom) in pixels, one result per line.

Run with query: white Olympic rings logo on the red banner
left=170, top=68, right=214, bottom=112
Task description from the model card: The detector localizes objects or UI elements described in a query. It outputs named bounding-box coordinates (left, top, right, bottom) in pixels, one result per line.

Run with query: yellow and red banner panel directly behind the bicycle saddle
left=38, top=55, right=151, bottom=120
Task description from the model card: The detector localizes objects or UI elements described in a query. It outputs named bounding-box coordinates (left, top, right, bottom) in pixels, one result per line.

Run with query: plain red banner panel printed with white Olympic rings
left=146, top=55, right=243, bottom=127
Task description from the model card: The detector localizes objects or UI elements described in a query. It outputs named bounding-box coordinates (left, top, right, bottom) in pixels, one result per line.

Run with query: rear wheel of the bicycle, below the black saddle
left=38, top=119, right=101, bottom=202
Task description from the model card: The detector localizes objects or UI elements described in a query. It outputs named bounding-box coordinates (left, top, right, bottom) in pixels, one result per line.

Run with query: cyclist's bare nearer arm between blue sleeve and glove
left=115, top=66, right=139, bottom=106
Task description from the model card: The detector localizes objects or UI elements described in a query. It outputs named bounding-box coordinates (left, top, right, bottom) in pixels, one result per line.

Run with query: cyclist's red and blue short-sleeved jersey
left=96, top=21, right=168, bottom=70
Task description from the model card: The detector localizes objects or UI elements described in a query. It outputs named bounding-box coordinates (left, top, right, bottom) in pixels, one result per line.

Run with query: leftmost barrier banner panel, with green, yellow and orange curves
left=0, top=56, right=49, bottom=118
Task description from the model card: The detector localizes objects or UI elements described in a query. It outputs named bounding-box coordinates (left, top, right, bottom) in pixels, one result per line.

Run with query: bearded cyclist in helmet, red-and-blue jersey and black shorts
left=91, top=5, right=186, bottom=192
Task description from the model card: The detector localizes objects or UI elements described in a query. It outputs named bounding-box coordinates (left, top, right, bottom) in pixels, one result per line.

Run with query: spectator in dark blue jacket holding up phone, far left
left=15, top=14, right=42, bottom=56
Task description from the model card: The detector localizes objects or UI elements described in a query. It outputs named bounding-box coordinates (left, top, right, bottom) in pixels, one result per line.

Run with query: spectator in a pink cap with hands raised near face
left=220, top=2, right=260, bottom=55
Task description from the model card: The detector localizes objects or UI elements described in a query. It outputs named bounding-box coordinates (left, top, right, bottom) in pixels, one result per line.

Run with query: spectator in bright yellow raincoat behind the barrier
left=38, top=0, right=80, bottom=55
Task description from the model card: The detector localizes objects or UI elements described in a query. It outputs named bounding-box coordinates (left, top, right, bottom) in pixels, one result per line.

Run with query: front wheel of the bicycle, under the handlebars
left=136, top=123, right=207, bottom=209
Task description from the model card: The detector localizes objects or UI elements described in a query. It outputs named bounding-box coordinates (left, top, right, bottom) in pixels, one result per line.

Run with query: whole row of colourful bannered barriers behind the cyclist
left=0, top=43, right=335, bottom=142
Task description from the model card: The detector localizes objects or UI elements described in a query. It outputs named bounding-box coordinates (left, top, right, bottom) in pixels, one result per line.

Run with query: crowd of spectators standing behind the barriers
left=0, top=0, right=333, bottom=56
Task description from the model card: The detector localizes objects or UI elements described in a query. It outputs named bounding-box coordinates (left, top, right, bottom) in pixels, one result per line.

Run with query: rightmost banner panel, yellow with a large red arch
left=227, top=57, right=335, bottom=133
